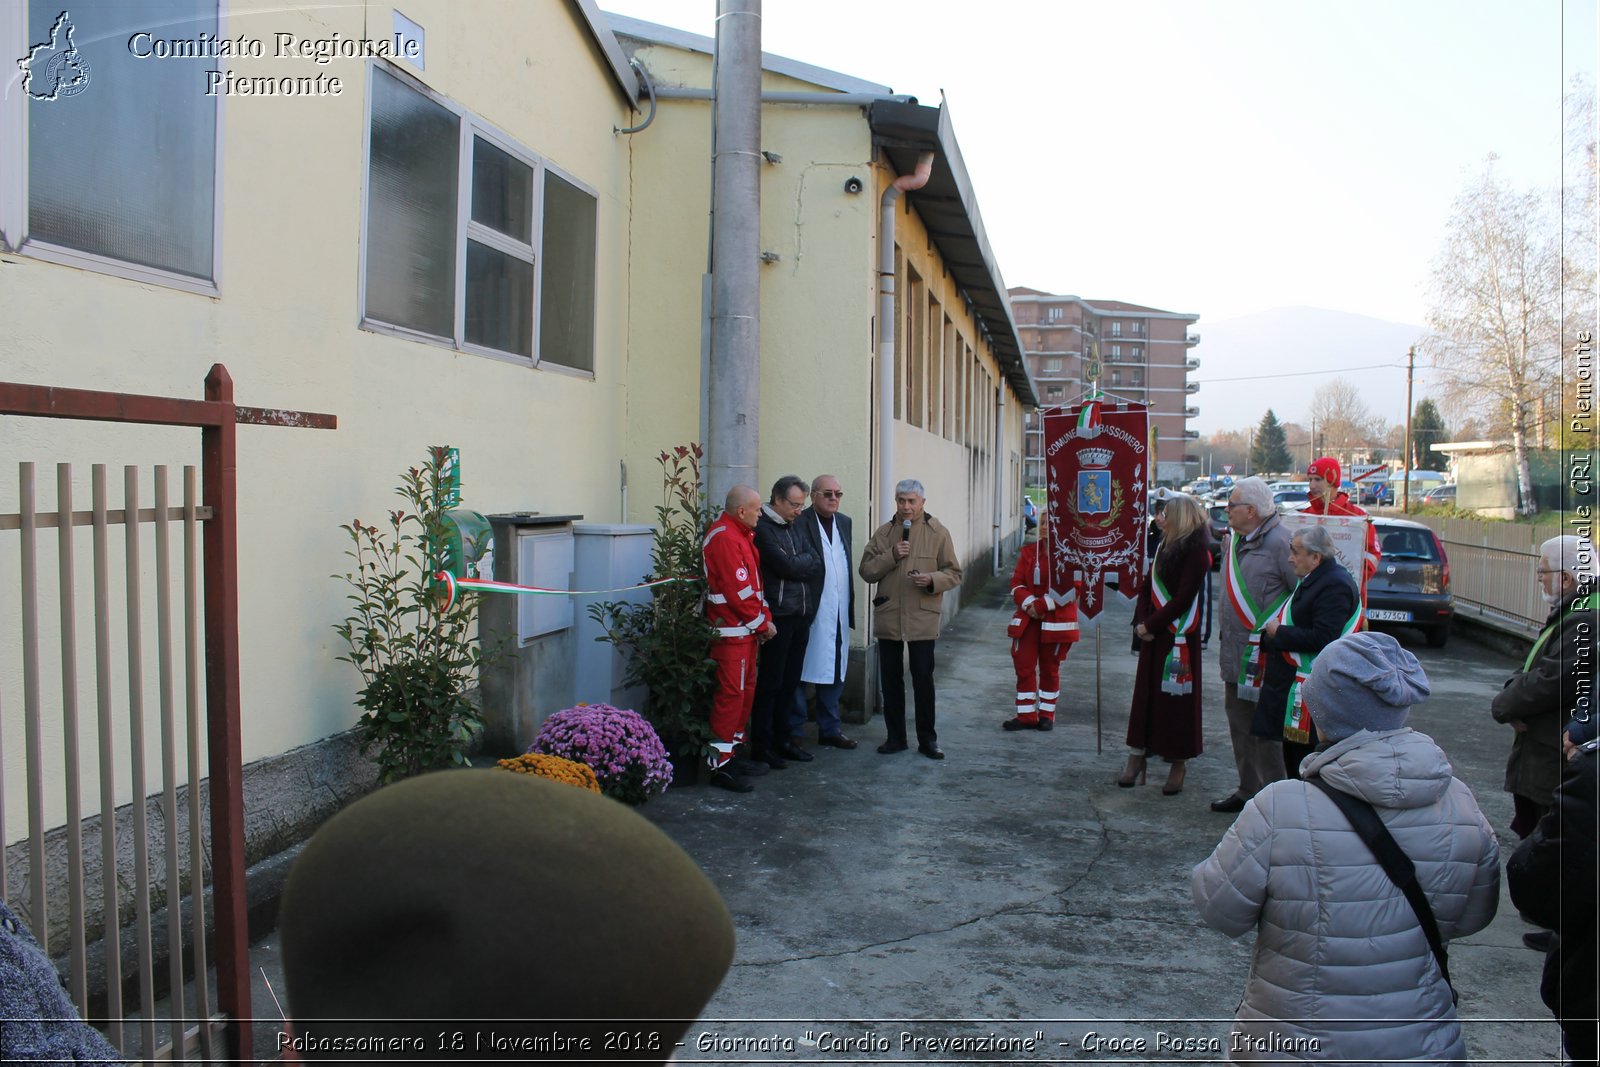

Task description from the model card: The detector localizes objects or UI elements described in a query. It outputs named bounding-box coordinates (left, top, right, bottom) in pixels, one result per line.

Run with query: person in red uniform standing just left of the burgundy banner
left=1000, top=525, right=1078, bottom=729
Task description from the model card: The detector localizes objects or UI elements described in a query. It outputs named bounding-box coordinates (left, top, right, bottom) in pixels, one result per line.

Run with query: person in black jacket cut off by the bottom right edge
left=1506, top=729, right=1600, bottom=1064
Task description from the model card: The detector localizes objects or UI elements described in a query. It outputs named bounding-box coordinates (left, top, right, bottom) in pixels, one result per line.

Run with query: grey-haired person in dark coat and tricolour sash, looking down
left=1250, top=526, right=1362, bottom=777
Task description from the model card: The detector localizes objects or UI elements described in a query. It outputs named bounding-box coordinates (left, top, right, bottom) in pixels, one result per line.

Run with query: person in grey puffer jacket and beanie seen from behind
left=1190, top=632, right=1499, bottom=1064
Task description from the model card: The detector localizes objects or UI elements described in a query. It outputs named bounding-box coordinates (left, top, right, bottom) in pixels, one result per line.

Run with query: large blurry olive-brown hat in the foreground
left=278, top=769, right=734, bottom=1062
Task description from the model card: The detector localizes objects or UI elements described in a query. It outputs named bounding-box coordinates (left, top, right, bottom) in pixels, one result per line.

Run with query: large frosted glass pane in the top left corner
left=27, top=0, right=218, bottom=280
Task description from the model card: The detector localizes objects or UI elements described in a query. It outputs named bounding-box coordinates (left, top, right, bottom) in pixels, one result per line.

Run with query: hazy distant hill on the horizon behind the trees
left=1189, top=307, right=1437, bottom=435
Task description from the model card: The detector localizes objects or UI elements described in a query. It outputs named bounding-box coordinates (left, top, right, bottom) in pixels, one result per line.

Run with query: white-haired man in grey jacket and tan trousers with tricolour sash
left=1211, top=478, right=1299, bottom=813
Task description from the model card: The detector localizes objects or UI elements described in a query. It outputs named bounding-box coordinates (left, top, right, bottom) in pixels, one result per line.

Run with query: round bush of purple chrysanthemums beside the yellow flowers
left=528, top=704, right=672, bottom=805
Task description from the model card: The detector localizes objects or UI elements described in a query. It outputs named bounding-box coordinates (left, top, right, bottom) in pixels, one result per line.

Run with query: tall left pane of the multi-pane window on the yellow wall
left=366, top=70, right=461, bottom=338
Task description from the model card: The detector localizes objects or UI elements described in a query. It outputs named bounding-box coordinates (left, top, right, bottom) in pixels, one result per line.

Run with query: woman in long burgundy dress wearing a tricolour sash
left=1117, top=493, right=1211, bottom=797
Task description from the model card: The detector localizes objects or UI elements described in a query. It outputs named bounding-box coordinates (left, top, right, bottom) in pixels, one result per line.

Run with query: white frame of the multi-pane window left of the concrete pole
left=357, top=59, right=600, bottom=379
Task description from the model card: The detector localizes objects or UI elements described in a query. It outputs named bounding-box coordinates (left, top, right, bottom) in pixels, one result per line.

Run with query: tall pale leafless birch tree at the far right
left=1427, top=157, right=1563, bottom=515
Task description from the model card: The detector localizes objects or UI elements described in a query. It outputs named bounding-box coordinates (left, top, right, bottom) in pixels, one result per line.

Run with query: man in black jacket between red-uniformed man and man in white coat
left=750, top=474, right=822, bottom=771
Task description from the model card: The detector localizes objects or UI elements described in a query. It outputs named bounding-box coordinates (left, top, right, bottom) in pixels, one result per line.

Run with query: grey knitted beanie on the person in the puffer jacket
left=1306, top=630, right=1432, bottom=742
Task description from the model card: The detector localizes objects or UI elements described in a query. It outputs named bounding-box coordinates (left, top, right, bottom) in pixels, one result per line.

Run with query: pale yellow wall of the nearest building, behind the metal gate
left=0, top=0, right=635, bottom=811
